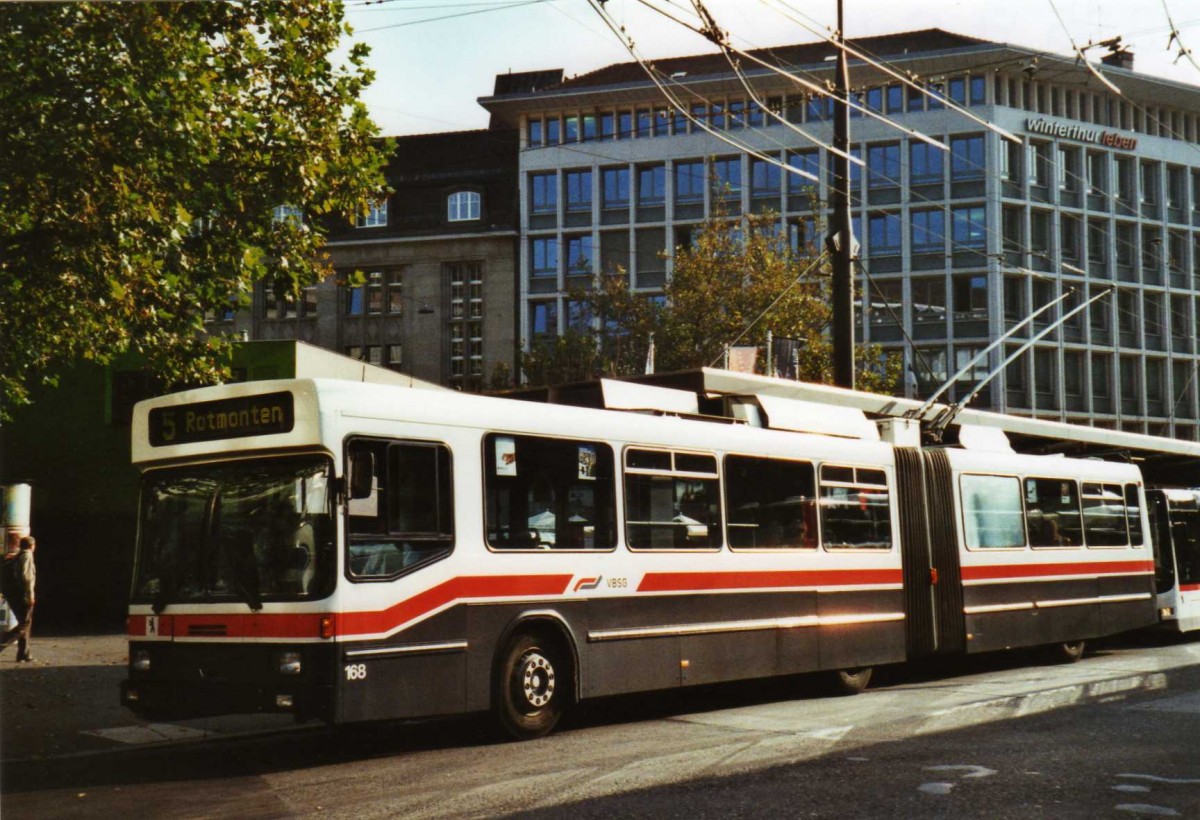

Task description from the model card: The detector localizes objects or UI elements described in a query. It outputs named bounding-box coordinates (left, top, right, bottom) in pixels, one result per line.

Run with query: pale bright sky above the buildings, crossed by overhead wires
left=336, top=0, right=1200, bottom=136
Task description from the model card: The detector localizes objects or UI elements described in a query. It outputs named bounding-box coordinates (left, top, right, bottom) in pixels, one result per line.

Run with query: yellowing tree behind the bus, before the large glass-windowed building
left=522, top=206, right=902, bottom=393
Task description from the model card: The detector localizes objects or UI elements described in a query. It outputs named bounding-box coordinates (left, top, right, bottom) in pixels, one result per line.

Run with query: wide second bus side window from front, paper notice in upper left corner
left=484, top=433, right=617, bottom=550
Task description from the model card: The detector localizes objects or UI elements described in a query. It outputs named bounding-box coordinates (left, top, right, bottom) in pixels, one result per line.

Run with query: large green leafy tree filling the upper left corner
left=0, top=0, right=384, bottom=418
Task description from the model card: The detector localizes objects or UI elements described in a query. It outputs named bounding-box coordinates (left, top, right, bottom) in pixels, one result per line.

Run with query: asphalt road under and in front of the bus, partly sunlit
left=0, top=642, right=1200, bottom=820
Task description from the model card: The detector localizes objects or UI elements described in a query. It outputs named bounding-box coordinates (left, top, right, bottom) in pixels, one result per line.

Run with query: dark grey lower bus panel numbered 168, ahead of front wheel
left=338, top=606, right=467, bottom=722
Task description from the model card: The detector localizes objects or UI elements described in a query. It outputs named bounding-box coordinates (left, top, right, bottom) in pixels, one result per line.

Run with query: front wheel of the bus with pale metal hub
left=493, top=634, right=566, bottom=741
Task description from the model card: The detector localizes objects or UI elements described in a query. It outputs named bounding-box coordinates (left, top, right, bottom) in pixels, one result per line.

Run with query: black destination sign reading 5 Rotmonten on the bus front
left=150, top=393, right=295, bottom=447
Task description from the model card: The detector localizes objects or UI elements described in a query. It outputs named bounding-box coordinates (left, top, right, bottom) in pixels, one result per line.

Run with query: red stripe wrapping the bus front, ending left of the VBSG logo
left=128, top=575, right=572, bottom=639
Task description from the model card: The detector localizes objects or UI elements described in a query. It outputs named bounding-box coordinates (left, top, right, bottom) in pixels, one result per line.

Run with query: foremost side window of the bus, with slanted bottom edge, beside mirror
left=347, top=439, right=454, bottom=579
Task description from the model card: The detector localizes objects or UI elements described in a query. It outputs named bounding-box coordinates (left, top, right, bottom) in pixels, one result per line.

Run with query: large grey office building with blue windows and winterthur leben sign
left=481, top=30, right=1200, bottom=439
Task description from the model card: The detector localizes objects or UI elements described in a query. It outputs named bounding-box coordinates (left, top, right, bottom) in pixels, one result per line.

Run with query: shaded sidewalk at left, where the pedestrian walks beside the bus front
left=0, top=633, right=296, bottom=760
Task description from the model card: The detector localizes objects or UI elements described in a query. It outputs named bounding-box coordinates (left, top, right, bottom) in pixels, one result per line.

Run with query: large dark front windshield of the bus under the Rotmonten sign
left=133, top=456, right=337, bottom=611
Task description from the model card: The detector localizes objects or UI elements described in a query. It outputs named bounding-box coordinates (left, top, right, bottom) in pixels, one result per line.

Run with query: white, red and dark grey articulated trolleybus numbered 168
left=121, top=379, right=1157, bottom=738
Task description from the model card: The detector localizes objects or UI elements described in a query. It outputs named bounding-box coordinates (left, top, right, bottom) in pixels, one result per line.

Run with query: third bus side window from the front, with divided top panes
left=625, top=449, right=721, bottom=550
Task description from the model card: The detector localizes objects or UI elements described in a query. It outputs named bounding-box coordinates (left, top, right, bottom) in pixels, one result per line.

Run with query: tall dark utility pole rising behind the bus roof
left=827, top=0, right=854, bottom=389
